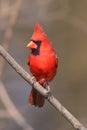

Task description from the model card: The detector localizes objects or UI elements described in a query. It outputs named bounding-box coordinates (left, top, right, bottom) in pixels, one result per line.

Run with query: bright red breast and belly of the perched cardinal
left=29, top=55, right=57, bottom=81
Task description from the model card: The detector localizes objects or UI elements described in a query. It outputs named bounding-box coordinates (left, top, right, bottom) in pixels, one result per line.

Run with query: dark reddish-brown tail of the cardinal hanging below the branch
left=28, top=88, right=45, bottom=107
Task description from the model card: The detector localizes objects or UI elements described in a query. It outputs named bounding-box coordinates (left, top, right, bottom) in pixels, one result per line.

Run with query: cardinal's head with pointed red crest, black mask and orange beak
left=27, top=22, right=52, bottom=55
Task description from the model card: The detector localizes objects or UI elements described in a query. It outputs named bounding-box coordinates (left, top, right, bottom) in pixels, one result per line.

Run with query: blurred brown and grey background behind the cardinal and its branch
left=0, top=0, right=87, bottom=130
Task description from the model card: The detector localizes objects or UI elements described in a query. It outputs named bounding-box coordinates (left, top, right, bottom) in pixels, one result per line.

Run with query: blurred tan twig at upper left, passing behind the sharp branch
left=0, top=0, right=22, bottom=77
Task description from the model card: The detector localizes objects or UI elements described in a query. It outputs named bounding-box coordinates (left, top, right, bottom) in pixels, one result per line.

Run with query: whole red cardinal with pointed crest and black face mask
left=27, top=22, right=58, bottom=107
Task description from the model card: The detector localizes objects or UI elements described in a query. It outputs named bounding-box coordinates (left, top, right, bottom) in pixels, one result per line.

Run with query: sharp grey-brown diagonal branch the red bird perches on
left=0, top=45, right=87, bottom=130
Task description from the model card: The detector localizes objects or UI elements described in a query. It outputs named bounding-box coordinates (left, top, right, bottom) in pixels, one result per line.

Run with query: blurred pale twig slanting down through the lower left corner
left=0, top=81, right=33, bottom=130
